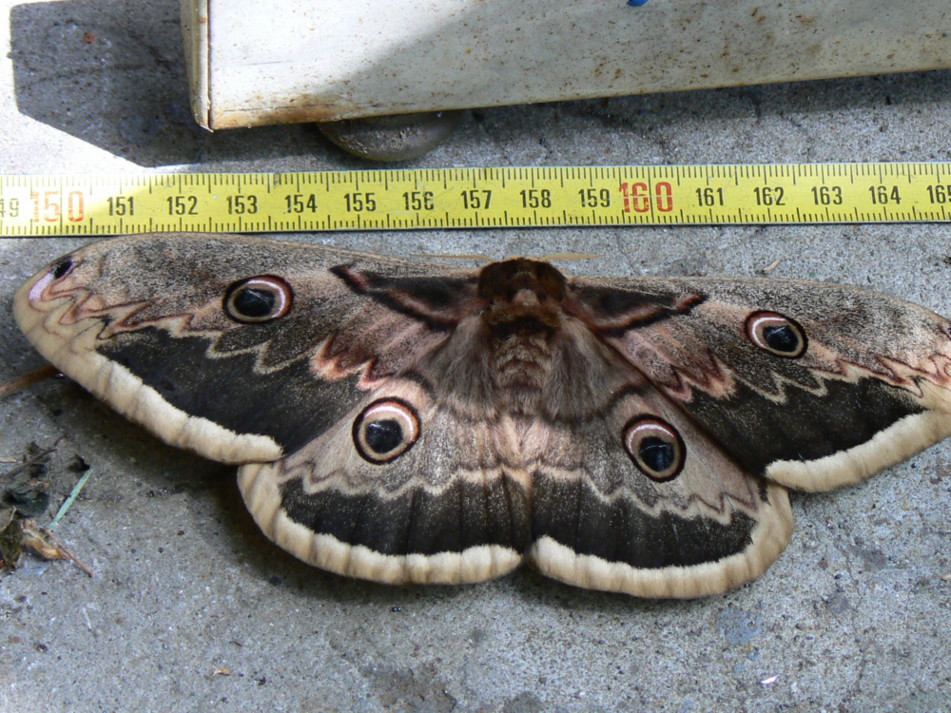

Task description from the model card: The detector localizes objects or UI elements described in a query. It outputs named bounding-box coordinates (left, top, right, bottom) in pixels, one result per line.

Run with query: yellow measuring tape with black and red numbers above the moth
left=0, top=163, right=951, bottom=237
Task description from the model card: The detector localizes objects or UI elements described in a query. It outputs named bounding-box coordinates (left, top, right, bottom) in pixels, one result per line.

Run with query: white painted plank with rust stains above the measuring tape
left=183, top=0, right=951, bottom=129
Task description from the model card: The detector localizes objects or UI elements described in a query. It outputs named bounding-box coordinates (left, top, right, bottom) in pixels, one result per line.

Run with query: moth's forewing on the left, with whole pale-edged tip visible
left=15, top=234, right=474, bottom=463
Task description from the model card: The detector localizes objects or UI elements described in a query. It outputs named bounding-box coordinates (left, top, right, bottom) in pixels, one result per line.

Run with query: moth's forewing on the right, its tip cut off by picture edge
left=577, top=278, right=951, bottom=490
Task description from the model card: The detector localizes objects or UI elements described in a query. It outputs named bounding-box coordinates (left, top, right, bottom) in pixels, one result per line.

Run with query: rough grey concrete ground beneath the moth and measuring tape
left=0, top=0, right=951, bottom=713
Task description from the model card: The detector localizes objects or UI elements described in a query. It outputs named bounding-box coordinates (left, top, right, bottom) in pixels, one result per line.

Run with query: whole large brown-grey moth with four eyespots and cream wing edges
left=15, top=235, right=951, bottom=597
